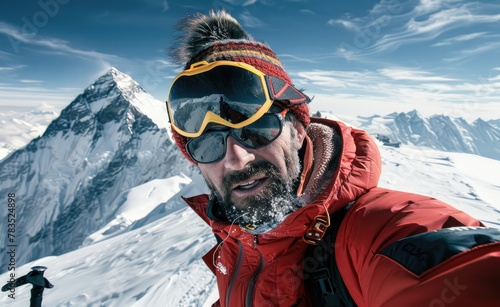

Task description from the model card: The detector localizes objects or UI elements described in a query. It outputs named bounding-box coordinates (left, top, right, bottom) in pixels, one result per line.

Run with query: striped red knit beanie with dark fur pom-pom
left=170, top=10, right=310, bottom=164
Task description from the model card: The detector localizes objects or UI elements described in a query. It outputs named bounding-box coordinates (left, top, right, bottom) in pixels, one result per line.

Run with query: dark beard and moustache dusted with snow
left=207, top=132, right=302, bottom=234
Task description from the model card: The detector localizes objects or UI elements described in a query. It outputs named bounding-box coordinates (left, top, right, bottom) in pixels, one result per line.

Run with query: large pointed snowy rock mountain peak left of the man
left=0, top=69, right=191, bottom=267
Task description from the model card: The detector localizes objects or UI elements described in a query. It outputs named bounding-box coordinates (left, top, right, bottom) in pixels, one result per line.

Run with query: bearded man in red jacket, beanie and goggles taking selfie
left=167, top=11, right=500, bottom=306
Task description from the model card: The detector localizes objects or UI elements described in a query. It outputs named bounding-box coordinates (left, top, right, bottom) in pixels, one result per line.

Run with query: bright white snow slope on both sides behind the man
left=0, top=142, right=500, bottom=306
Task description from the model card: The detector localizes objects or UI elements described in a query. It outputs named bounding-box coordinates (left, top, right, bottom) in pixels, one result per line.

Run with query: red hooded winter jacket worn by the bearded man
left=185, top=119, right=500, bottom=307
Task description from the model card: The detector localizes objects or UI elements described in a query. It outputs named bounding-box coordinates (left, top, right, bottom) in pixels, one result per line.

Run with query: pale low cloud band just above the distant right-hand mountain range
left=294, top=67, right=500, bottom=120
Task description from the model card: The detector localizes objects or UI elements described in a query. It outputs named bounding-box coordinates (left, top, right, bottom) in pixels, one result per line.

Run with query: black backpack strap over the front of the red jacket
left=304, top=201, right=356, bottom=307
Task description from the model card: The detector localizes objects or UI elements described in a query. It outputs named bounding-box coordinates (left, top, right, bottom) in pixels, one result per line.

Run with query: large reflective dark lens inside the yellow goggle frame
left=168, top=66, right=267, bottom=133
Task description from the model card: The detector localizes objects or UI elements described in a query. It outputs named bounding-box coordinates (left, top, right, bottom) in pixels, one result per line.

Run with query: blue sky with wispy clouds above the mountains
left=0, top=0, right=500, bottom=120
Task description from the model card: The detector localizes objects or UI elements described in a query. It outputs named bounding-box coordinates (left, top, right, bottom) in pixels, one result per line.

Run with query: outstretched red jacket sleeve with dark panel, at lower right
left=335, top=188, right=500, bottom=307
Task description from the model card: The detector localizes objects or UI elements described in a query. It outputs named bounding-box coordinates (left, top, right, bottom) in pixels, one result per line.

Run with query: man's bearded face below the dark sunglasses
left=199, top=121, right=305, bottom=232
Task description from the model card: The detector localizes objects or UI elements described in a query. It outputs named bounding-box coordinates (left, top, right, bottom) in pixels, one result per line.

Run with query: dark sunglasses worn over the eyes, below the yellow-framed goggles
left=186, top=109, right=288, bottom=164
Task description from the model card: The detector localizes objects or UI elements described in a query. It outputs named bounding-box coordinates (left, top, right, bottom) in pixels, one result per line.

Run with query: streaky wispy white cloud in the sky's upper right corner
left=328, top=0, right=500, bottom=60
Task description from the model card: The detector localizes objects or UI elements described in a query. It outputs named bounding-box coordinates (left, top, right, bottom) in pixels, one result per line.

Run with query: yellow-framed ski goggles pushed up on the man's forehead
left=167, top=61, right=310, bottom=138
